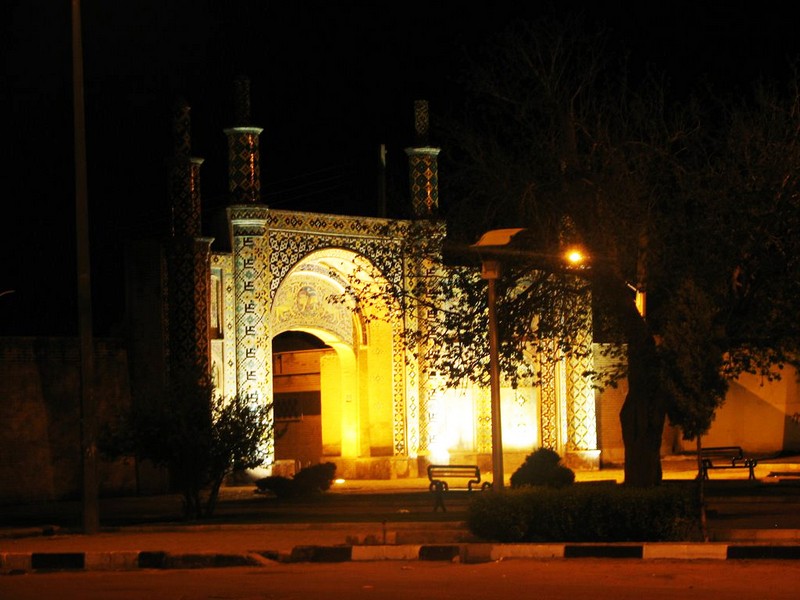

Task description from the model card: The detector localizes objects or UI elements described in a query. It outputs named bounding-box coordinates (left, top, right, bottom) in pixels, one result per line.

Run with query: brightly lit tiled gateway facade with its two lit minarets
left=209, top=81, right=597, bottom=477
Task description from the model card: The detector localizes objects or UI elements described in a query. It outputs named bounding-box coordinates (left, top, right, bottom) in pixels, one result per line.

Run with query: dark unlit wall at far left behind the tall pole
left=0, top=337, right=136, bottom=504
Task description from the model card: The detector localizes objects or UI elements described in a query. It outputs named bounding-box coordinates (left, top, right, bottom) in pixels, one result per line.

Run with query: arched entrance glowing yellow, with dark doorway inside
left=270, top=248, right=404, bottom=477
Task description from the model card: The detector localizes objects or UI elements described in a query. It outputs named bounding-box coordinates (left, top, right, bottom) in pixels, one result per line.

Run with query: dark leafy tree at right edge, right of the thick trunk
left=661, top=73, right=800, bottom=432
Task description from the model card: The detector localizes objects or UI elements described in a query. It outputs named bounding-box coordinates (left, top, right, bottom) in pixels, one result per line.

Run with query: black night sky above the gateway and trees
left=0, top=0, right=800, bottom=335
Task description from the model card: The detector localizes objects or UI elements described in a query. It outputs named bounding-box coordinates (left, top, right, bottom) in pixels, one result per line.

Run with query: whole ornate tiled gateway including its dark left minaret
left=167, top=82, right=599, bottom=478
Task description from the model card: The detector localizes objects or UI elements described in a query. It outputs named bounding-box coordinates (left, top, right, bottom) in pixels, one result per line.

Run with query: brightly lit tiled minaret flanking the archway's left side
left=225, top=79, right=274, bottom=462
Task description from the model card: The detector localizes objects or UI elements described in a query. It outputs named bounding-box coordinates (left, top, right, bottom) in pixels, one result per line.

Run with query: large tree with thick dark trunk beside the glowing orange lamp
left=434, top=14, right=692, bottom=485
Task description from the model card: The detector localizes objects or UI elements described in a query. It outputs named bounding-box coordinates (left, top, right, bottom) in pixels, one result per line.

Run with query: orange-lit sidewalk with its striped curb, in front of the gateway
left=0, top=459, right=800, bottom=573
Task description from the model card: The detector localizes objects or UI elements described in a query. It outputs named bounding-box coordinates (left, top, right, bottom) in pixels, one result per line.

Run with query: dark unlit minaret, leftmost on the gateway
left=165, top=101, right=212, bottom=379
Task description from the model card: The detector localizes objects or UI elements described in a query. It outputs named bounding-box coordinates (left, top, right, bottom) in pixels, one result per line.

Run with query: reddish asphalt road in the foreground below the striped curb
left=0, top=559, right=800, bottom=600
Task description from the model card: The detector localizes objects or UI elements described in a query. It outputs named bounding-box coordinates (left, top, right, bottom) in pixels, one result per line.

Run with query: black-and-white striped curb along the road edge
left=0, top=542, right=800, bottom=575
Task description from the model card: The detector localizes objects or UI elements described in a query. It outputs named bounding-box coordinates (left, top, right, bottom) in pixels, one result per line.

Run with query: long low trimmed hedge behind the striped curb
left=467, top=484, right=698, bottom=542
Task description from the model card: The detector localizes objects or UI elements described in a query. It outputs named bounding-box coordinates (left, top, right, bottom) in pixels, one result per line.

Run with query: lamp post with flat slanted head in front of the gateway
left=472, top=229, right=524, bottom=491
